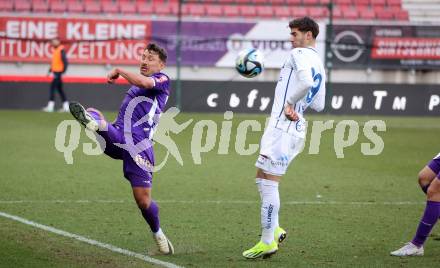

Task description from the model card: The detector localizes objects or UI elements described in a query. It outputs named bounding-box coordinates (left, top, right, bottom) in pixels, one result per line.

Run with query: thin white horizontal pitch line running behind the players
left=0, top=200, right=426, bottom=206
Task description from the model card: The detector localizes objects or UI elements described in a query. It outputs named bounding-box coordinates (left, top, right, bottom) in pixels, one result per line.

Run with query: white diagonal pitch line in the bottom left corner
left=0, top=211, right=182, bottom=268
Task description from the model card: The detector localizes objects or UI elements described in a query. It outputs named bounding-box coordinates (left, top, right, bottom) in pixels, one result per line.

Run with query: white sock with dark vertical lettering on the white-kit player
left=261, top=179, right=280, bottom=244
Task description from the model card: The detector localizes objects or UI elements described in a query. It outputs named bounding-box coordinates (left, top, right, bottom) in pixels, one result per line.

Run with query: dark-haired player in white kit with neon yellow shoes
left=243, top=17, right=325, bottom=259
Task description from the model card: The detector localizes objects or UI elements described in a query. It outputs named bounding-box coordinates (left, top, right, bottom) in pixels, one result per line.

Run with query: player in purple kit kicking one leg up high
left=69, top=43, right=174, bottom=254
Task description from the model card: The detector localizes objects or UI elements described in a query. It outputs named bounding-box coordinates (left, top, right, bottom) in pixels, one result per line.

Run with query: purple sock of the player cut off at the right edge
left=411, top=201, right=440, bottom=247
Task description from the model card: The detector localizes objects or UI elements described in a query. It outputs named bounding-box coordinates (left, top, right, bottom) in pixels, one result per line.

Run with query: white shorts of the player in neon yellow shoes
left=255, top=116, right=305, bottom=176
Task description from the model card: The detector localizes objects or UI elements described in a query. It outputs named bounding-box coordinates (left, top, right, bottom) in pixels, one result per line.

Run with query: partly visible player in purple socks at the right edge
left=391, top=153, right=440, bottom=257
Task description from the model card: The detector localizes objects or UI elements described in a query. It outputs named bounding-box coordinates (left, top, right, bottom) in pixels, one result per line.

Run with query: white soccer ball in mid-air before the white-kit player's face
left=235, top=48, right=264, bottom=78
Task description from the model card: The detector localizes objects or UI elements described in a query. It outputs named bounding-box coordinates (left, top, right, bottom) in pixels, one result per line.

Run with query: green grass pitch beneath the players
left=0, top=111, right=440, bottom=267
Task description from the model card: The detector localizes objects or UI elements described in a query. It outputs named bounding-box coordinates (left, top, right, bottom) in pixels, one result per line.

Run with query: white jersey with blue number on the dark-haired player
left=271, top=47, right=325, bottom=137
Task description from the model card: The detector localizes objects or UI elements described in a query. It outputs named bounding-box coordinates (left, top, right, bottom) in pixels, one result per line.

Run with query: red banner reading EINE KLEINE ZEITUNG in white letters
left=0, top=17, right=151, bottom=64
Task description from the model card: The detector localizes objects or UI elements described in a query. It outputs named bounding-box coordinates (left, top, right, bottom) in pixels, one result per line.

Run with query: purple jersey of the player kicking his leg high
left=114, top=73, right=170, bottom=139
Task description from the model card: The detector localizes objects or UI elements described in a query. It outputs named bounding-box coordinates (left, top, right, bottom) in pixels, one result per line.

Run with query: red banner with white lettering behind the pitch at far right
left=371, top=37, right=440, bottom=60
